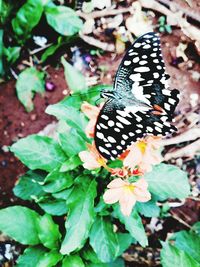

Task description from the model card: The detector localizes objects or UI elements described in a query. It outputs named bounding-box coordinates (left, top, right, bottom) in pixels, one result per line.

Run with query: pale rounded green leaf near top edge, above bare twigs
left=45, top=4, right=83, bottom=36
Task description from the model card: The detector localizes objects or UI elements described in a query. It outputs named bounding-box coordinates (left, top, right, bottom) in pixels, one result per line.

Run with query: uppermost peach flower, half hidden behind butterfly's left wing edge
left=81, top=102, right=101, bottom=138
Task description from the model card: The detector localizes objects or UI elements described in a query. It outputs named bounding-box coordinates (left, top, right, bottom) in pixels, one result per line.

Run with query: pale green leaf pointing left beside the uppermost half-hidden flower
left=45, top=101, right=88, bottom=132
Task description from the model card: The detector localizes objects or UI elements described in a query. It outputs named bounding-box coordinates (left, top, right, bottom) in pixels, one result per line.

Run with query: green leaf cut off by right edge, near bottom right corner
left=172, top=231, right=200, bottom=263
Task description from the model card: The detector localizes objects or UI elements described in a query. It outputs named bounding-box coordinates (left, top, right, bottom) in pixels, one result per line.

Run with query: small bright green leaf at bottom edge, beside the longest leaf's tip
left=36, top=250, right=63, bottom=267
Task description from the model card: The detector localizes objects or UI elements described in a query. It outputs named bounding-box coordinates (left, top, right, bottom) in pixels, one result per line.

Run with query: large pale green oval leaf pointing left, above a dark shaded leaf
left=10, top=134, right=66, bottom=172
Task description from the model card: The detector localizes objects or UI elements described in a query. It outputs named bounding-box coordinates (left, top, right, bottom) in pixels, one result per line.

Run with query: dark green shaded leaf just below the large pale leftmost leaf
left=13, top=171, right=45, bottom=200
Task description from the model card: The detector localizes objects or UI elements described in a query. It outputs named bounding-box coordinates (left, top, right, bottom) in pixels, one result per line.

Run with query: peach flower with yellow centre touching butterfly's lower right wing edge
left=123, top=136, right=163, bottom=172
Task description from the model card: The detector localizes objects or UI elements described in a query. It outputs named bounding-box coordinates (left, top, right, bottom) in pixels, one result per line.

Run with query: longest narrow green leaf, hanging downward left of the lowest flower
left=60, top=176, right=97, bottom=254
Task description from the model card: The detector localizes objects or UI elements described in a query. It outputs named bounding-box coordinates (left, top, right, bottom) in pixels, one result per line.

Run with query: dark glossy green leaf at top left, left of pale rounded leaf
left=12, top=0, right=43, bottom=42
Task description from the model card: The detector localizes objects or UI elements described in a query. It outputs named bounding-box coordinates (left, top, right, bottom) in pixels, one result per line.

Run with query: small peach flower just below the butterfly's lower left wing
left=79, top=143, right=109, bottom=170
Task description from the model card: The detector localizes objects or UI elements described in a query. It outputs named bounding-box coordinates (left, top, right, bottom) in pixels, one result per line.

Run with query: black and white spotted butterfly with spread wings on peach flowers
left=95, top=32, right=179, bottom=160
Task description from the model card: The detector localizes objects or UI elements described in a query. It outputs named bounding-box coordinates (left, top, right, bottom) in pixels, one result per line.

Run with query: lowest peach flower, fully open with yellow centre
left=103, top=178, right=151, bottom=216
